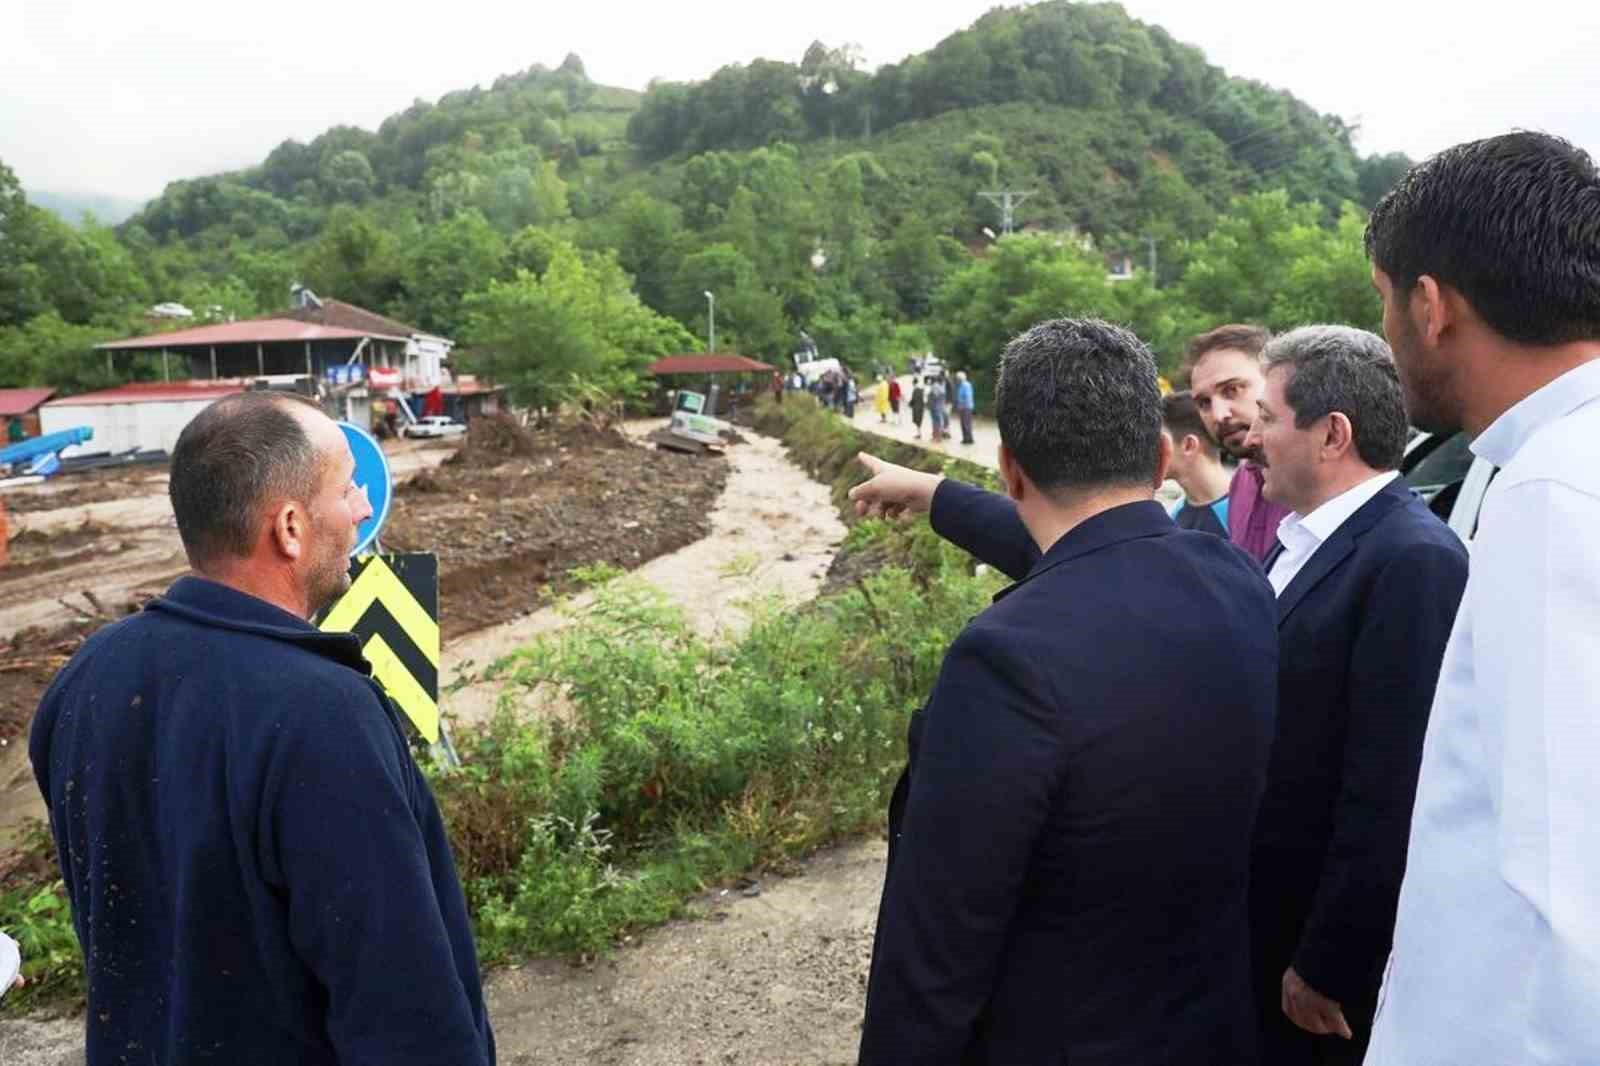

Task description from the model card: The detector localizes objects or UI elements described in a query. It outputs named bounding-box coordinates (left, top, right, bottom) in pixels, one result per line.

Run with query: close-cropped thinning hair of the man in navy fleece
left=166, top=391, right=323, bottom=568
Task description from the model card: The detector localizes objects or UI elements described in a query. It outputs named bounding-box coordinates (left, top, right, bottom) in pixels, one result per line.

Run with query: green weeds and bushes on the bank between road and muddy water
left=434, top=399, right=997, bottom=964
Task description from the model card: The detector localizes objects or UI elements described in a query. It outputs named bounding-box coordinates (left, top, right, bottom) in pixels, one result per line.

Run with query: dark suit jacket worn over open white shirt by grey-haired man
left=1251, top=479, right=1467, bottom=1024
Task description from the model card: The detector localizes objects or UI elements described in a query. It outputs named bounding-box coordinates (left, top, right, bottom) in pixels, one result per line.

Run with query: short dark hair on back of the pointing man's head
left=995, top=319, right=1162, bottom=493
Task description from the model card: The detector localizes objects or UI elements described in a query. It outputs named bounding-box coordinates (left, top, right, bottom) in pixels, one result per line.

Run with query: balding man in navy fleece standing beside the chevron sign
left=30, top=392, right=494, bottom=1066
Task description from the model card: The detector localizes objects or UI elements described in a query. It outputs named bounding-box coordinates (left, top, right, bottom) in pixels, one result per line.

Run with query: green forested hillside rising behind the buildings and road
left=0, top=0, right=1408, bottom=400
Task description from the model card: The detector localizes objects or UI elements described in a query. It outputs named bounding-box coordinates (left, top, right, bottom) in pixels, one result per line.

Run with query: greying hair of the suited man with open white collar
left=1266, top=325, right=1406, bottom=471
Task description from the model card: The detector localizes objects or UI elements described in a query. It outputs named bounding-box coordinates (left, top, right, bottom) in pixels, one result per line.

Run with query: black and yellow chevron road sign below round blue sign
left=322, top=552, right=440, bottom=744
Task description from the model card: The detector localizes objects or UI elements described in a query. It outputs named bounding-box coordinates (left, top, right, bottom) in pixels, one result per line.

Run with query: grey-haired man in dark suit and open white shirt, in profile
left=1245, top=327, right=1467, bottom=1066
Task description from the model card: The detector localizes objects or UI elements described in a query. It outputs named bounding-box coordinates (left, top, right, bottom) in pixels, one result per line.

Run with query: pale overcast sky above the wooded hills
left=0, top=0, right=1600, bottom=198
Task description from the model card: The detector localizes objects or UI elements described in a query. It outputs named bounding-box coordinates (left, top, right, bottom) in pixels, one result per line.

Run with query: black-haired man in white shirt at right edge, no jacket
left=1366, top=133, right=1600, bottom=1066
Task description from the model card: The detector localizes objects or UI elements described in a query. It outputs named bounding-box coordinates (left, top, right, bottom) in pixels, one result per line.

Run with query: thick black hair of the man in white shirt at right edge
left=1366, top=133, right=1600, bottom=344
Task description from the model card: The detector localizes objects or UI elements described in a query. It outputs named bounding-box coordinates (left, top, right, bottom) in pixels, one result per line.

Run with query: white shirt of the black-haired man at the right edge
left=1366, top=362, right=1600, bottom=1066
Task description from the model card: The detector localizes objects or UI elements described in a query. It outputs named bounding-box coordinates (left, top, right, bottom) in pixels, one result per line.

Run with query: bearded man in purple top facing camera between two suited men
left=1186, top=323, right=1290, bottom=562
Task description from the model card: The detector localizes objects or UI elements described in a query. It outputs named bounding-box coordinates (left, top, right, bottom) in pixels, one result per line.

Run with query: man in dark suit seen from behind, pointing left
left=858, top=320, right=1277, bottom=1066
